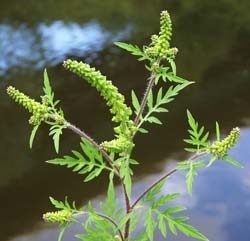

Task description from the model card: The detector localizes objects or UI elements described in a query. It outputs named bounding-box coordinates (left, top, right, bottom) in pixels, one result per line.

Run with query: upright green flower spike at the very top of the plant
left=145, top=11, right=178, bottom=61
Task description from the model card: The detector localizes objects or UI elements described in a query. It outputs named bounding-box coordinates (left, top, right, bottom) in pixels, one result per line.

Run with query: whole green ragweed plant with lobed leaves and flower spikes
left=7, top=11, right=241, bottom=241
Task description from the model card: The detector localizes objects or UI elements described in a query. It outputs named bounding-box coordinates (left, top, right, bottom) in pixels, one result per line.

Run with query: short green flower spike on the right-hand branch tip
left=209, top=127, right=240, bottom=158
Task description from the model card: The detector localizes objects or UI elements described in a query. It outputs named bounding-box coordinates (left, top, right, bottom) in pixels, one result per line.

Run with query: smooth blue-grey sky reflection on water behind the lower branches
left=12, top=128, right=250, bottom=241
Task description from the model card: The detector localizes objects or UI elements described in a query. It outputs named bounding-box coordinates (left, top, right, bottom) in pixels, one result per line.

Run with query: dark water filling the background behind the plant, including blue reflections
left=0, top=0, right=250, bottom=241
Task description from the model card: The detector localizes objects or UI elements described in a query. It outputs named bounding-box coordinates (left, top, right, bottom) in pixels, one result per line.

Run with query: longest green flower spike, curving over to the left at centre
left=63, top=60, right=134, bottom=153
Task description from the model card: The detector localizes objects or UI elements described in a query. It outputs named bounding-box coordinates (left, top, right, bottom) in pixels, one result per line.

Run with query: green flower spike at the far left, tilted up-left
left=7, top=86, right=50, bottom=125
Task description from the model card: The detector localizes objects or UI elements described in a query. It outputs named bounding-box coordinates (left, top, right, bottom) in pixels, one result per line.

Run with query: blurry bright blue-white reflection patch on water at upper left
left=0, top=21, right=132, bottom=77
